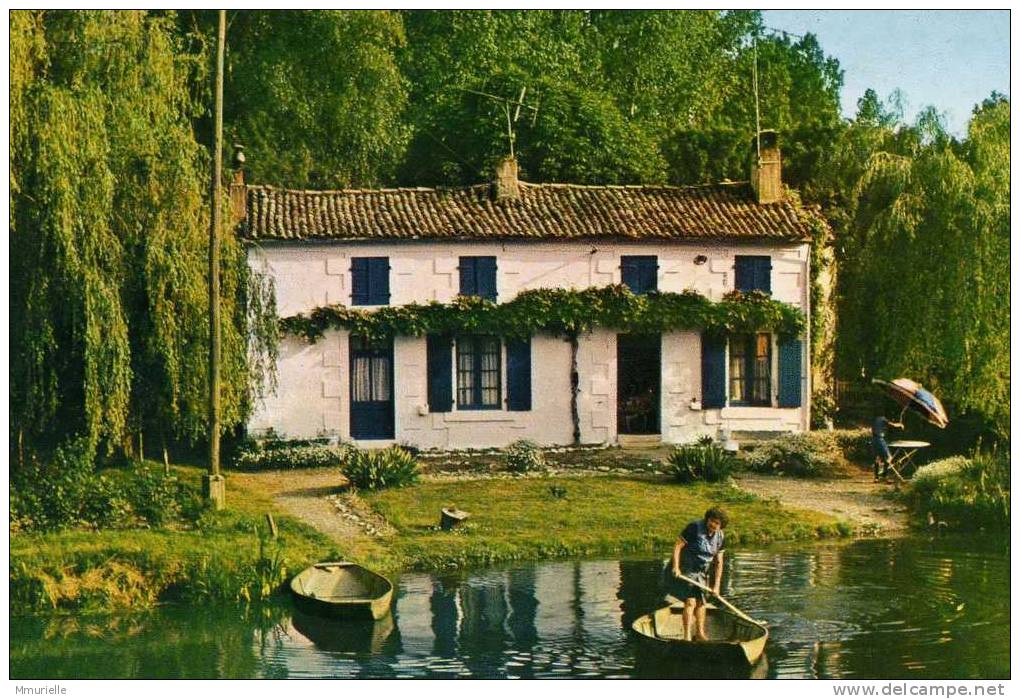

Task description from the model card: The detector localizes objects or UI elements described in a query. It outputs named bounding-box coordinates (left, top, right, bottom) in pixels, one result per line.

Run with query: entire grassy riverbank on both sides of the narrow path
left=10, top=457, right=851, bottom=612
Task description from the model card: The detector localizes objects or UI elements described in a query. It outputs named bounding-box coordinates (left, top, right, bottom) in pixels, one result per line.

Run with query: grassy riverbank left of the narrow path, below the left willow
left=9, top=467, right=335, bottom=612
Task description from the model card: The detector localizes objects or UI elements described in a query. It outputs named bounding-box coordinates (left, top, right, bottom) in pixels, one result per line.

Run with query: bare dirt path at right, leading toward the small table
left=736, top=472, right=908, bottom=536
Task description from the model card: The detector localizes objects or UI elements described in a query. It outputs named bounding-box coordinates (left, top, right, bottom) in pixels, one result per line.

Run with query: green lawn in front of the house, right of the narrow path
left=362, top=477, right=851, bottom=569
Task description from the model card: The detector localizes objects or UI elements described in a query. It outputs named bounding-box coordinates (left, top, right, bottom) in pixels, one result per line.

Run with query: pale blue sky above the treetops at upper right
left=762, top=10, right=1010, bottom=136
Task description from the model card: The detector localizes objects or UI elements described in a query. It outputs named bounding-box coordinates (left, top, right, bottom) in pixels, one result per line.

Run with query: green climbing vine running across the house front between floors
left=281, top=285, right=805, bottom=342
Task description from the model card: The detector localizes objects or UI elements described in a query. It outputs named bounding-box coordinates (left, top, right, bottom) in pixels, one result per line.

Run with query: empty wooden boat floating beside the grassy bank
left=291, top=561, right=393, bottom=619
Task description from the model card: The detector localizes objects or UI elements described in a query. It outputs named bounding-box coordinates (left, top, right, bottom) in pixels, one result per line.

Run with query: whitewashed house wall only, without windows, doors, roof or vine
left=248, top=240, right=810, bottom=449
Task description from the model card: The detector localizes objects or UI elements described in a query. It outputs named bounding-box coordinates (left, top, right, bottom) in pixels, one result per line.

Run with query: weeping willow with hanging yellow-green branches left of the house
left=10, top=11, right=275, bottom=457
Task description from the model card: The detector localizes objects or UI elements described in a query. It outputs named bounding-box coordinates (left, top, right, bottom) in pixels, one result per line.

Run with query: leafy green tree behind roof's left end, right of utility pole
left=223, top=10, right=410, bottom=189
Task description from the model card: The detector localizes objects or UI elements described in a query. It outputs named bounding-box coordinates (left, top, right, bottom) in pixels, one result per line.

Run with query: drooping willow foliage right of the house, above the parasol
left=817, top=89, right=1010, bottom=438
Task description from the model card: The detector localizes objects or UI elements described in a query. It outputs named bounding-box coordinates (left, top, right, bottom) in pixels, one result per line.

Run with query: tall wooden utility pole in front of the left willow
left=202, top=10, right=226, bottom=509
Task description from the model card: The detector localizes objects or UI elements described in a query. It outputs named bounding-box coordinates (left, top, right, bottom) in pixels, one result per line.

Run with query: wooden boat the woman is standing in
left=631, top=605, right=768, bottom=667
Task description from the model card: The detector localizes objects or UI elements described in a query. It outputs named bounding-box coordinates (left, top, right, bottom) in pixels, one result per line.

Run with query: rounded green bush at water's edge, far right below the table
left=908, top=452, right=1010, bottom=532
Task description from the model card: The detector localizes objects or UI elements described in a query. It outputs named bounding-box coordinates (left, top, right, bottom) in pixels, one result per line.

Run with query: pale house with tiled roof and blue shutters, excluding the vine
left=232, top=137, right=820, bottom=449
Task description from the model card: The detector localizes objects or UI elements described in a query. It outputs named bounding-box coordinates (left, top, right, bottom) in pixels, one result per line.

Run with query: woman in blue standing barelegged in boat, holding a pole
left=667, top=507, right=729, bottom=641
